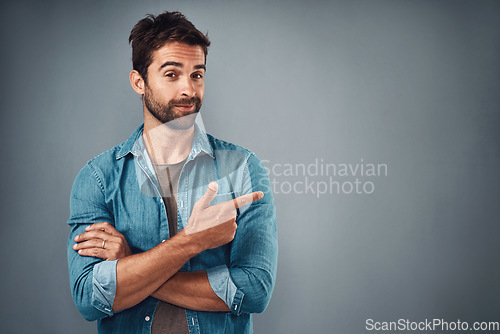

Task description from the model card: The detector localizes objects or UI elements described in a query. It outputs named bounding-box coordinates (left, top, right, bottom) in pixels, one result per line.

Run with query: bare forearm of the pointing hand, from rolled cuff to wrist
left=113, top=232, right=200, bottom=312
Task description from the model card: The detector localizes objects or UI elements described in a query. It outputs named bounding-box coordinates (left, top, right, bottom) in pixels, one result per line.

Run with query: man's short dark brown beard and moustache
left=144, top=86, right=201, bottom=130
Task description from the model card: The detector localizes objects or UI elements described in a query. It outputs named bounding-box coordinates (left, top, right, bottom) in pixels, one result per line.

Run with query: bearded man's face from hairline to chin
left=144, top=42, right=205, bottom=129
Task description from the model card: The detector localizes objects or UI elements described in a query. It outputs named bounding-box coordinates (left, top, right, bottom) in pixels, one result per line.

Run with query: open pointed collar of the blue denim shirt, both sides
left=116, top=123, right=215, bottom=161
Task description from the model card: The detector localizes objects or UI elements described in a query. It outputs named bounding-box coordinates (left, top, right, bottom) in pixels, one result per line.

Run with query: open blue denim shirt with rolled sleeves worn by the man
left=67, top=125, right=278, bottom=334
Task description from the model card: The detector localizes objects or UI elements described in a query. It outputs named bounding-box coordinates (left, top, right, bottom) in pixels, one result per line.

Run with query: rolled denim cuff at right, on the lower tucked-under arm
left=207, top=265, right=245, bottom=315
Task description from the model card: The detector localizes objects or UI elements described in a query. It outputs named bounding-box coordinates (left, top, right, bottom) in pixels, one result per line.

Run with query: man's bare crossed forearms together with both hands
left=73, top=182, right=263, bottom=312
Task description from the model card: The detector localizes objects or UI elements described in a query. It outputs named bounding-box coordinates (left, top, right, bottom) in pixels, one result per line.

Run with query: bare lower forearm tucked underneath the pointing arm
left=152, top=271, right=229, bottom=312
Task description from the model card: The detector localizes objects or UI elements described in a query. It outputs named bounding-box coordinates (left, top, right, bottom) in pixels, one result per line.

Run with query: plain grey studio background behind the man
left=0, top=1, right=500, bottom=334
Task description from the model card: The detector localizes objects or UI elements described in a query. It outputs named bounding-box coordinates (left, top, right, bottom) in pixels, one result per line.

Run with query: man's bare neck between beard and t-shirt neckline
left=142, top=110, right=194, bottom=164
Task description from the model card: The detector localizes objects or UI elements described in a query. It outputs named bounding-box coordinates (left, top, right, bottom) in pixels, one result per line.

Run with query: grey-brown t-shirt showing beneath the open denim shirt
left=151, top=160, right=189, bottom=334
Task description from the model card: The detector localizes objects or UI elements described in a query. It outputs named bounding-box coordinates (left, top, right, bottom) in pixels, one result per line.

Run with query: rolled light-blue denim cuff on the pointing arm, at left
left=92, top=260, right=118, bottom=316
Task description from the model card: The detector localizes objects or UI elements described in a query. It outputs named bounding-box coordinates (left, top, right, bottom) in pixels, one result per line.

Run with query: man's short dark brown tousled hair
left=128, top=12, right=210, bottom=82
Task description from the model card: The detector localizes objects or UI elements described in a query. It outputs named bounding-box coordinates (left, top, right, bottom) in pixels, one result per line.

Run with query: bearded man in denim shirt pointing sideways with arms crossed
left=68, top=12, right=277, bottom=334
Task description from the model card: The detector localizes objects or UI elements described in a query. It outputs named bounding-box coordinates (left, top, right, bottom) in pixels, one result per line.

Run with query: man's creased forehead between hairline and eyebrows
left=152, top=42, right=205, bottom=66
